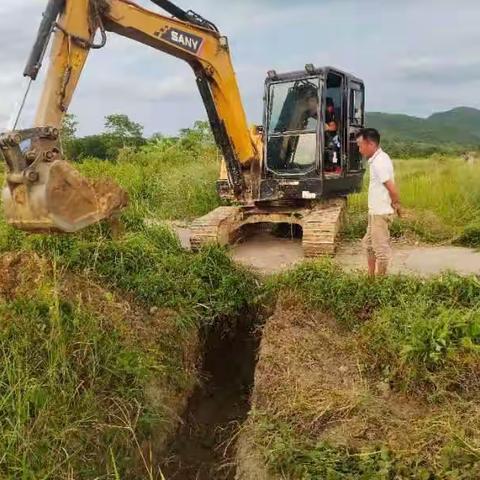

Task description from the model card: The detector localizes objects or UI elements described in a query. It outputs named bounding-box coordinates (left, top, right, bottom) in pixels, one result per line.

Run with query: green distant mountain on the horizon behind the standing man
left=366, top=107, right=480, bottom=146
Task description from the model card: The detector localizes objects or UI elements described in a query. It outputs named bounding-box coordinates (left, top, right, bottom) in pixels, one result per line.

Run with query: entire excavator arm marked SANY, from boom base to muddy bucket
left=0, top=0, right=259, bottom=232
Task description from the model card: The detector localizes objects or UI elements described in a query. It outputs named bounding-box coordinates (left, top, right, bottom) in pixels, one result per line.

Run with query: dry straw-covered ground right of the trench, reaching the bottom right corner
left=238, top=299, right=480, bottom=480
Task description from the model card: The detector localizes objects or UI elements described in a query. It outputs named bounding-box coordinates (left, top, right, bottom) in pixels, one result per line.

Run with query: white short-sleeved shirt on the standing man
left=368, top=148, right=395, bottom=215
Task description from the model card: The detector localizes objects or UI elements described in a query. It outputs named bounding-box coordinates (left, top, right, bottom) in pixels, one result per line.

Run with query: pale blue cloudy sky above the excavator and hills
left=0, top=0, right=480, bottom=135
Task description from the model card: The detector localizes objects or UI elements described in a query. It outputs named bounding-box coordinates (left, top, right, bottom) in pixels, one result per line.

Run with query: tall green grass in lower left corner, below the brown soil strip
left=0, top=295, right=159, bottom=480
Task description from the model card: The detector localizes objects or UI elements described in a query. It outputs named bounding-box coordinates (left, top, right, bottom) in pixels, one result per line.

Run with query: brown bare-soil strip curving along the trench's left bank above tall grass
left=0, top=252, right=201, bottom=472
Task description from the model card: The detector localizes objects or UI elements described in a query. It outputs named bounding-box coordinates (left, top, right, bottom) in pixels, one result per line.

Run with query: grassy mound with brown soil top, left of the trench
left=0, top=253, right=199, bottom=479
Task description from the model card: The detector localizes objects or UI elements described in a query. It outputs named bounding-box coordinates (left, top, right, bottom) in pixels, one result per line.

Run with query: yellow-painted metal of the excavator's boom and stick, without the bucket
left=35, top=0, right=259, bottom=168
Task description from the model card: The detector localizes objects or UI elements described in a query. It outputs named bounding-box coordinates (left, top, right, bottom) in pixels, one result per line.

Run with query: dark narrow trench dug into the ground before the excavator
left=161, top=319, right=261, bottom=480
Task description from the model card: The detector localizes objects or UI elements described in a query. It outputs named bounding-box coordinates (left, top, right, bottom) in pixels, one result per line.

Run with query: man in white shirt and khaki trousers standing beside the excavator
left=357, top=128, right=400, bottom=276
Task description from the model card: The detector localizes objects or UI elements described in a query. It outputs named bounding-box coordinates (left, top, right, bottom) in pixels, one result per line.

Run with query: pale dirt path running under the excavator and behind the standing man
left=228, top=233, right=480, bottom=276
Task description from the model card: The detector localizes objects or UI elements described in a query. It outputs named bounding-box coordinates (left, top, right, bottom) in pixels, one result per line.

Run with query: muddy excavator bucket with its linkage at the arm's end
left=0, top=127, right=128, bottom=233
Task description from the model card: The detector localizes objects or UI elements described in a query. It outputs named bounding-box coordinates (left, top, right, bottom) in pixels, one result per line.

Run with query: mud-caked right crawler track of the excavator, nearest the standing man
left=302, top=198, right=347, bottom=258
